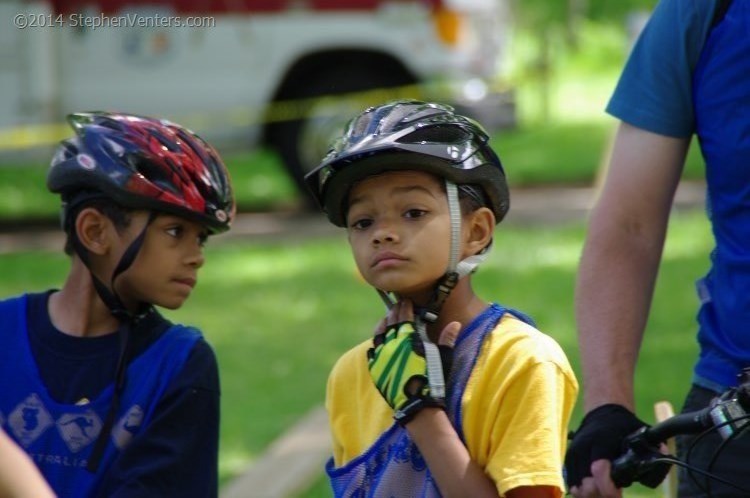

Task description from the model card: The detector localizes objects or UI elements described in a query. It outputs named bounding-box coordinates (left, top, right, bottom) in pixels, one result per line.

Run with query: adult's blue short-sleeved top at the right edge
left=607, top=0, right=750, bottom=391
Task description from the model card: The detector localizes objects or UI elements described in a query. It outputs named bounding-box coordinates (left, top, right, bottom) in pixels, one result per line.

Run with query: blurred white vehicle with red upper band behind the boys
left=0, top=0, right=515, bottom=204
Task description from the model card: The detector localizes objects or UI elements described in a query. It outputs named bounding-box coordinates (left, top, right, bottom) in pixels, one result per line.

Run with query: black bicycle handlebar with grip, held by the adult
left=610, top=369, right=750, bottom=488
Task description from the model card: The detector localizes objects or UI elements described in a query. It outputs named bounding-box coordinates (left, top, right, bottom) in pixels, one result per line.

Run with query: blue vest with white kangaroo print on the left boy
left=0, top=296, right=200, bottom=496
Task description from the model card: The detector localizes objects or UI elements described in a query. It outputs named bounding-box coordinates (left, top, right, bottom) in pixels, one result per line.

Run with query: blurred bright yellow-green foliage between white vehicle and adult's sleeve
left=512, top=0, right=656, bottom=124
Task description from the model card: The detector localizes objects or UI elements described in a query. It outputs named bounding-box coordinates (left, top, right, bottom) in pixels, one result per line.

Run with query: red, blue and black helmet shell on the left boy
left=47, top=112, right=235, bottom=233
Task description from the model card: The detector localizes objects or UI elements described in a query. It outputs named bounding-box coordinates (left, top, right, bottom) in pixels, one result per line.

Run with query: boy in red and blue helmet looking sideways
left=0, top=113, right=235, bottom=497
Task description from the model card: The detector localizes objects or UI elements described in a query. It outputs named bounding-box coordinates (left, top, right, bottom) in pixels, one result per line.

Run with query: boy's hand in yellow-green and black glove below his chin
left=367, top=301, right=461, bottom=425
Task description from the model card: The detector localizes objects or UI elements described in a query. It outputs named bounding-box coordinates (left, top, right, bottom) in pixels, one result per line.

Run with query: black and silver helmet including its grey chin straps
left=305, top=100, right=509, bottom=397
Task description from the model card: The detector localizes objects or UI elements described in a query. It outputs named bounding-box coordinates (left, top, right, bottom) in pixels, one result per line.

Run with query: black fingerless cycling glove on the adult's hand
left=565, top=404, right=647, bottom=489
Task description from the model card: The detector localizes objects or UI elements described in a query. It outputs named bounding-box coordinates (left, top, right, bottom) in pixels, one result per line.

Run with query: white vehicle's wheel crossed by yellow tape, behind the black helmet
left=269, top=66, right=410, bottom=210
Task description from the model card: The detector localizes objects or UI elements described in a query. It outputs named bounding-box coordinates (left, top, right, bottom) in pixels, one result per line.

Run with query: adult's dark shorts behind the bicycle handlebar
left=677, top=385, right=750, bottom=498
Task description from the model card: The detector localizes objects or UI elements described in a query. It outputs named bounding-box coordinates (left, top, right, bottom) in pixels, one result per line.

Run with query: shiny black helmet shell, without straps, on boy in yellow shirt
left=305, top=100, right=509, bottom=227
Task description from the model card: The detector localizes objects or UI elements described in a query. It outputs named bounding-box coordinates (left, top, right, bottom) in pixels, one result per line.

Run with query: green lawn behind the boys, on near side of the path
left=0, top=206, right=711, bottom=497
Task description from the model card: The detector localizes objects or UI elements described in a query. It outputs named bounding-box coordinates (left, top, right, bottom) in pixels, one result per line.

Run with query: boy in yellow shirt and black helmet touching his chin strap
left=307, top=101, right=578, bottom=498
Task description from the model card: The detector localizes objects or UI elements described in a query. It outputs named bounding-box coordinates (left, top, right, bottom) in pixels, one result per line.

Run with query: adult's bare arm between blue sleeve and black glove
left=575, top=123, right=690, bottom=412
